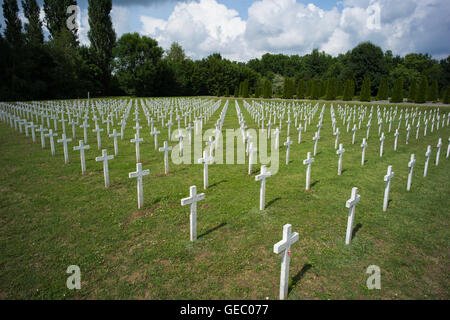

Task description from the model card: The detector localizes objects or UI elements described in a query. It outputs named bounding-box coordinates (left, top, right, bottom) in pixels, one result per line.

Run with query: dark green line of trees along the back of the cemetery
left=0, top=0, right=450, bottom=103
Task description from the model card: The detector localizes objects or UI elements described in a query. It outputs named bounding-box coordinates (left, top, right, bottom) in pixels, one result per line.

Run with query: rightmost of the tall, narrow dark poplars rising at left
left=88, top=0, right=116, bottom=94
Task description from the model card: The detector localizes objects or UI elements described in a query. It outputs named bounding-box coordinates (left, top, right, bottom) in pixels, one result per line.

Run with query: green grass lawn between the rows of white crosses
left=0, top=99, right=450, bottom=300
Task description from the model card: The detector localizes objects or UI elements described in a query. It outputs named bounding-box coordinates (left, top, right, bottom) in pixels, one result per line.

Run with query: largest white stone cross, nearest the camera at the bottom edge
left=273, top=224, right=299, bottom=300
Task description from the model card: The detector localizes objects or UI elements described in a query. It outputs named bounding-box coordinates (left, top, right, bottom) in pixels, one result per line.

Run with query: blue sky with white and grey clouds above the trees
left=0, top=0, right=450, bottom=61
